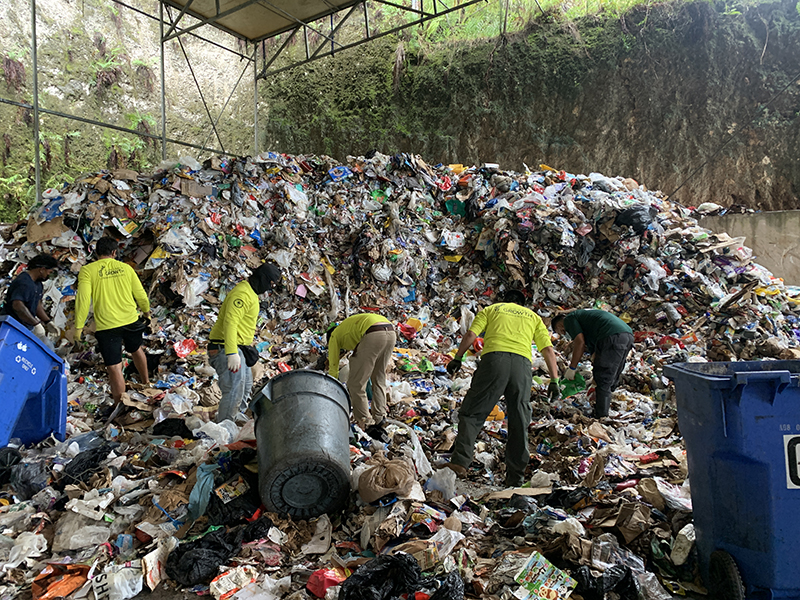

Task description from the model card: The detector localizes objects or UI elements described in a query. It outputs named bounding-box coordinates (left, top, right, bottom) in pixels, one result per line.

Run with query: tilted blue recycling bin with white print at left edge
left=0, top=316, right=67, bottom=447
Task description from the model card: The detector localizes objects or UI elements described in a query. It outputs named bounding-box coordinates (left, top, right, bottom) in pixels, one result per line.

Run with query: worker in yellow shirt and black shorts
left=75, top=237, right=150, bottom=402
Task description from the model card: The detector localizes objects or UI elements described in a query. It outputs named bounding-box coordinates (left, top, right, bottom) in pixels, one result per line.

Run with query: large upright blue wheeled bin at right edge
left=664, top=361, right=800, bottom=598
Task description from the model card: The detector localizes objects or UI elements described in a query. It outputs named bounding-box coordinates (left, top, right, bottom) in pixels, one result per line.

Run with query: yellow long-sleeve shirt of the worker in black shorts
left=75, top=258, right=150, bottom=331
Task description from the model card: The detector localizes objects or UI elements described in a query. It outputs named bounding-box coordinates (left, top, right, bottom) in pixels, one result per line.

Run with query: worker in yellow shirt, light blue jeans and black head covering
left=208, top=263, right=281, bottom=423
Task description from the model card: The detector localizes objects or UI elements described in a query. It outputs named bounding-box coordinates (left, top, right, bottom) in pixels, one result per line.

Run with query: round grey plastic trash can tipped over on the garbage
left=252, top=370, right=350, bottom=519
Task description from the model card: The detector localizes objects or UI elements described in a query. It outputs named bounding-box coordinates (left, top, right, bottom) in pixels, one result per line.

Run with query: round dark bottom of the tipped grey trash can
left=262, top=457, right=350, bottom=519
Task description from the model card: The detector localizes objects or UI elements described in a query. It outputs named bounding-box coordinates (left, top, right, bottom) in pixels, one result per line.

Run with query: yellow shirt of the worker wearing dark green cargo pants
left=469, top=302, right=553, bottom=360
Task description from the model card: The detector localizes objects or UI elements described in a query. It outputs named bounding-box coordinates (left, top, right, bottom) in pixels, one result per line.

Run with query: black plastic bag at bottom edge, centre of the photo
left=339, top=554, right=464, bottom=600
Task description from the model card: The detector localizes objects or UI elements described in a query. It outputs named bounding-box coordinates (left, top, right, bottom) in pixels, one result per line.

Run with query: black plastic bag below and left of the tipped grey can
left=166, top=528, right=243, bottom=587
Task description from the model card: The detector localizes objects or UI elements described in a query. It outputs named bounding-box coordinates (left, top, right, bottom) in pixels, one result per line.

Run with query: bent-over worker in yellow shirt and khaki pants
left=327, top=313, right=397, bottom=439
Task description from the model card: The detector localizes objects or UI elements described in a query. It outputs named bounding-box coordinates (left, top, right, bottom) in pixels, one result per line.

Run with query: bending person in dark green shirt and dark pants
left=550, top=310, right=633, bottom=419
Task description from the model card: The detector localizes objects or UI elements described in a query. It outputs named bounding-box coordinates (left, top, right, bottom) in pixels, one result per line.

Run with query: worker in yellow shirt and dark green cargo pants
left=447, top=290, right=560, bottom=487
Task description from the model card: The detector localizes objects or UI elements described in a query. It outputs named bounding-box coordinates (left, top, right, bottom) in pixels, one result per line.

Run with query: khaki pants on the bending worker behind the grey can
left=347, top=329, right=397, bottom=428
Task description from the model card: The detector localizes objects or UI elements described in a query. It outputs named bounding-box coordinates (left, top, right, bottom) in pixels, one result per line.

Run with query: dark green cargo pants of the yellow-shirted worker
left=450, top=352, right=533, bottom=487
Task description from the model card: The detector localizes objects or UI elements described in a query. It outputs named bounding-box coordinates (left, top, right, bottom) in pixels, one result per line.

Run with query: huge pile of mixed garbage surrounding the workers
left=0, top=152, right=800, bottom=600
